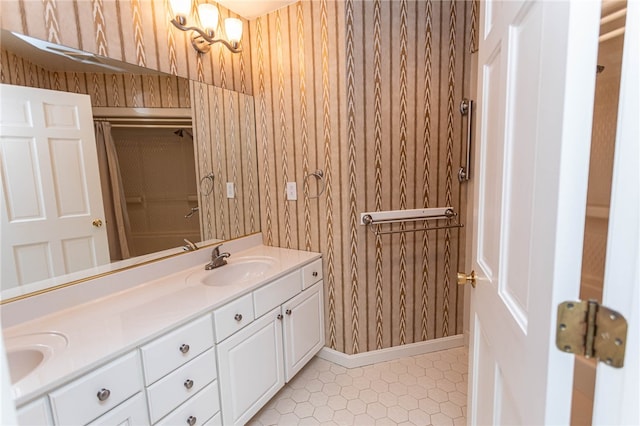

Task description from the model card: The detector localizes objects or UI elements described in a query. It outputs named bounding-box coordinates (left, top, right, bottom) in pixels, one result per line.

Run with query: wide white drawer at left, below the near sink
left=49, top=352, right=142, bottom=425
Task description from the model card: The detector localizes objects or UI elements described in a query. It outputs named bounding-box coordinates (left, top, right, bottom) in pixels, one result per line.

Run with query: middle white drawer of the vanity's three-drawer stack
left=147, top=349, right=216, bottom=423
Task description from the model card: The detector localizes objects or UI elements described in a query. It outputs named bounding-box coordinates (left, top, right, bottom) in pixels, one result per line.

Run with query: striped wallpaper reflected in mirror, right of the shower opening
left=190, top=81, right=260, bottom=240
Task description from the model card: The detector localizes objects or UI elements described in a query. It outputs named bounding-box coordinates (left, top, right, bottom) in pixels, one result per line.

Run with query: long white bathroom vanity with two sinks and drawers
left=3, top=245, right=324, bottom=426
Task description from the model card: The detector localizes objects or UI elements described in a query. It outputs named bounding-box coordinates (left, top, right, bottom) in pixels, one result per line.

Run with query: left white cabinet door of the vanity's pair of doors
left=218, top=307, right=284, bottom=425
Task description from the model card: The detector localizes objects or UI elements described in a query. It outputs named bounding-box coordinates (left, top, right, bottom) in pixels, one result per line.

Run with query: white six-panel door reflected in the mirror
left=0, top=84, right=109, bottom=290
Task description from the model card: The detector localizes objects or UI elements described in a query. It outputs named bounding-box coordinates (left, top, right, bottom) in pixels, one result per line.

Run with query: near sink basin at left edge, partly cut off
left=5, top=332, right=68, bottom=383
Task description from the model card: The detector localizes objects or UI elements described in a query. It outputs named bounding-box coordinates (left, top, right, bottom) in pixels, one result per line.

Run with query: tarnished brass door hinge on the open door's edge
left=556, top=300, right=627, bottom=368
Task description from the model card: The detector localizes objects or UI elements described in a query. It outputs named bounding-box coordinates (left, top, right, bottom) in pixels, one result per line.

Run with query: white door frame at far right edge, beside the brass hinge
left=593, top=1, right=640, bottom=425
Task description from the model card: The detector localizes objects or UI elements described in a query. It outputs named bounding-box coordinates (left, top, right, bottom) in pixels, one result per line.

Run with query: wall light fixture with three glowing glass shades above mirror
left=171, top=0, right=242, bottom=53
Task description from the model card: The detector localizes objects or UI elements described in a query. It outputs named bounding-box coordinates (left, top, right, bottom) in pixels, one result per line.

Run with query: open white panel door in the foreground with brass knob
left=467, top=1, right=600, bottom=425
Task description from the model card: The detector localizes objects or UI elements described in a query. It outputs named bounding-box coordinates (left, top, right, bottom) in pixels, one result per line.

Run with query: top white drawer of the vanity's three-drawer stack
left=140, top=315, right=213, bottom=386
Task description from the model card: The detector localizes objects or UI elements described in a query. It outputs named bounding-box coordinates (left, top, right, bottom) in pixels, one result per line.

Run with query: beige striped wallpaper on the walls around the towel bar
left=250, top=0, right=475, bottom=354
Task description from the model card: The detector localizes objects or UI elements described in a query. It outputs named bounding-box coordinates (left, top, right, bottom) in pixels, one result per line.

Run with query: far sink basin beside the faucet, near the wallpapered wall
left=189, top=256, right=276, bottom=286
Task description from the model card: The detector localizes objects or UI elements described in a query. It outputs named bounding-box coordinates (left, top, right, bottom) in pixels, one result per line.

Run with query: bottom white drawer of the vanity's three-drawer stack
left=157, top=381, right=220, bottom=426
